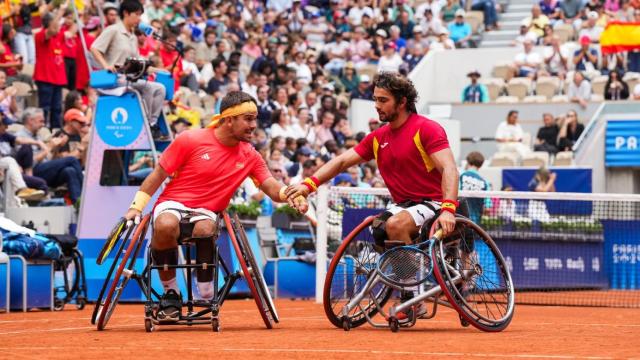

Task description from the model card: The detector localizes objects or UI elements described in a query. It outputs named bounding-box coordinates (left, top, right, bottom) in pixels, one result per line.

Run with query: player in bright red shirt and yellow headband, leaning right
left=125, top=91, right=306, bottom=321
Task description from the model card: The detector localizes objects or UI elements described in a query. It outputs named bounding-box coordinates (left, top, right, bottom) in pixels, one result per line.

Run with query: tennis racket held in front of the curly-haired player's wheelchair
left=376, top=230, right=442, bottom=288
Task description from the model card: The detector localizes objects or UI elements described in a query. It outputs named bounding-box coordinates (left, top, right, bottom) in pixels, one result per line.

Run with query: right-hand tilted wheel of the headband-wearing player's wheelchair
left=222, top=211, right=278, bottom=329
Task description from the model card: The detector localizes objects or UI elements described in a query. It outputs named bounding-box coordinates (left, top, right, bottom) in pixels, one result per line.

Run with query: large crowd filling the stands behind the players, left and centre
left=0, top=0, right=490, bottom=211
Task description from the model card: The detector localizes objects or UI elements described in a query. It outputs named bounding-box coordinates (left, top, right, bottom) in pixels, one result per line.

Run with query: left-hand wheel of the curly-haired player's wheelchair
left=322, top=216, right=393, bottom=329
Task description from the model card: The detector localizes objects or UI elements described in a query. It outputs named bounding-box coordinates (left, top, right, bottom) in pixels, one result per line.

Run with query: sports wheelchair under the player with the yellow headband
left=91, top=209, right=279, bottom=332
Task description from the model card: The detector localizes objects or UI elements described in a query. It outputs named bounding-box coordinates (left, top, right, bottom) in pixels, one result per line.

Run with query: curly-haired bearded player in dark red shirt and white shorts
left=285, top=72, right=458, bottom=318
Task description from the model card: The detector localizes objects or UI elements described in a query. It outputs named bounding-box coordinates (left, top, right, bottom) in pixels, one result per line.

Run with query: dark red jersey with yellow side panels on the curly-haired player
left=354, top=114, right=449, bottom=203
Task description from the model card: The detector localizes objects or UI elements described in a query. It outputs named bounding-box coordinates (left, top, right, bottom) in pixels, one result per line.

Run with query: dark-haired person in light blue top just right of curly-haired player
left=460, top=151, right=491, bottom=225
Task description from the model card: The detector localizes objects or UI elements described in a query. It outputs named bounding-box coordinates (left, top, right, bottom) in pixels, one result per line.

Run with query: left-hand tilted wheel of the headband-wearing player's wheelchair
left=97, top=214, right=151, bottom=330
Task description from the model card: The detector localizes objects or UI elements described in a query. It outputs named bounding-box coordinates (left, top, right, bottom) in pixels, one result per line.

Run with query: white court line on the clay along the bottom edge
left=5, top=344, right=613, bottom=360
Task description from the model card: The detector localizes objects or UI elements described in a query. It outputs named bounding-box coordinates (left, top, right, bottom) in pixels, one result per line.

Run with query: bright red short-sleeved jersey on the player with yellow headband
left=158, top=128, right=271, bottom=212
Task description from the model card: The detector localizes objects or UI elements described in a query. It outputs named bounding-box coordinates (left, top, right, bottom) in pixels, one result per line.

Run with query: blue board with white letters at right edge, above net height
left=604, top=120, right=640, bottom=167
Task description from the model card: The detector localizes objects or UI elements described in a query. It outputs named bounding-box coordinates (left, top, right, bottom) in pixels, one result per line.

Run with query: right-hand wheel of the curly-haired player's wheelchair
left=432, top=216, right=515, bottom=332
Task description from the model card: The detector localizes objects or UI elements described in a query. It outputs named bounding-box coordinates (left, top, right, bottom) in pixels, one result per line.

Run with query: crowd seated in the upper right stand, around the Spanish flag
left=462, top=0, right=640, bottom=107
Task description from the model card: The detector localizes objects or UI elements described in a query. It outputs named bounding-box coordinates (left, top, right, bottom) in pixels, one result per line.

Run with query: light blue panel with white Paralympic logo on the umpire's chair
left=95, top=93, right=144, bottom=147
